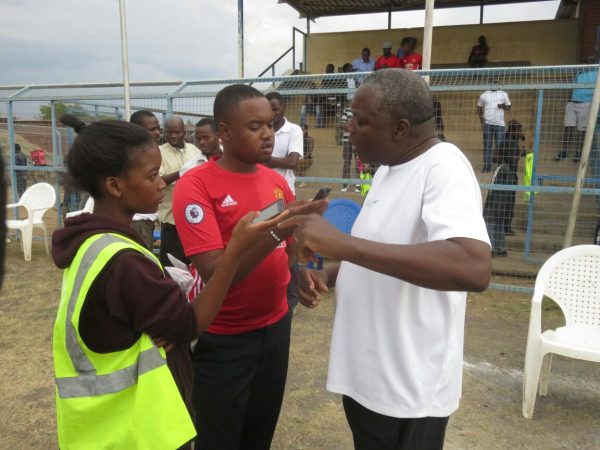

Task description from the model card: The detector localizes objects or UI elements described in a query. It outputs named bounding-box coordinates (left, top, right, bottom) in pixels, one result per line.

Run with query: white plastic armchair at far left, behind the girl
left=6, top=183, right=56, bottom=261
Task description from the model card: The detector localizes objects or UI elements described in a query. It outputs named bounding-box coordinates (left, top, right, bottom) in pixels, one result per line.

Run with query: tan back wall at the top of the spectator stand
left=308, top=19, right=580, bottom=73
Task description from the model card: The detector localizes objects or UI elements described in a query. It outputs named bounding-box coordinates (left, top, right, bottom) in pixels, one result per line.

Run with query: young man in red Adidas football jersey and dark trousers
left=173, top=85, right=326, bottom=450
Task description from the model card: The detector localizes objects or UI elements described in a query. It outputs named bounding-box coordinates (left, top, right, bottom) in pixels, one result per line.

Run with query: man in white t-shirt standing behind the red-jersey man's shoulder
left=265, top=92, right=304, bottom=194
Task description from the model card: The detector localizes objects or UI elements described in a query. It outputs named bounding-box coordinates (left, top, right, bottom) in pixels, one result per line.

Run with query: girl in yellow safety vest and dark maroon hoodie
left=52, top=115, right=289, bottom=449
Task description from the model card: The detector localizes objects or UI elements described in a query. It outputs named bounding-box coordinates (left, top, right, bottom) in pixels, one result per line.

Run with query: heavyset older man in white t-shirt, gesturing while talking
left=280, top=69, right=491, bottom=450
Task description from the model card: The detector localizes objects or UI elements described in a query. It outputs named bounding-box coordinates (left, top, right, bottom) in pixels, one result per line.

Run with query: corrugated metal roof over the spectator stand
left=278, top=0, right=560, bottom=19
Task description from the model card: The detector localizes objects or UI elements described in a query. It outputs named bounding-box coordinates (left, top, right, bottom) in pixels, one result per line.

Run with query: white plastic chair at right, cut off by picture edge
left=523, top=245, right=600, bottom=419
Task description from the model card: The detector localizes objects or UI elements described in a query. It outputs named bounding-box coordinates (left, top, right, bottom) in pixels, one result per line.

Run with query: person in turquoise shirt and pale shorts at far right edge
left=554, top=55, right=598, bottom=161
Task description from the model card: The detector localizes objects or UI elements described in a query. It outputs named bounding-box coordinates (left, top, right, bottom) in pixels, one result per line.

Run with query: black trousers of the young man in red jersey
left=192, top=311, right=292, bottom=450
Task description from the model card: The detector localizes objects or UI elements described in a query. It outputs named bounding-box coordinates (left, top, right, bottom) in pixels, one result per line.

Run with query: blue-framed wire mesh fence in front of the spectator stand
left=0, top=66, right=600, bottom=291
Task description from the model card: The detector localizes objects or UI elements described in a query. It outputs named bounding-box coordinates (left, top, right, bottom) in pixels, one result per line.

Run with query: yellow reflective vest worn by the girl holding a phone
left=52, top=233, right=196, bottom=449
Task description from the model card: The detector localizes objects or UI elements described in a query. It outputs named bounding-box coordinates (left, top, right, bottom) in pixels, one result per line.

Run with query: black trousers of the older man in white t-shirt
left=343, top=395, right=448, bottom=450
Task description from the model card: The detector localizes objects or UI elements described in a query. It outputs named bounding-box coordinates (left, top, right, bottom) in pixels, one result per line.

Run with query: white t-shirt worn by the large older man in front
left=327, top=143, right=489, bottom=418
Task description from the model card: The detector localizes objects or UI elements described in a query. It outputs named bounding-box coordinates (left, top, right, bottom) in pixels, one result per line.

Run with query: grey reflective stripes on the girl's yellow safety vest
left=56, top=234, right=166, bottom=398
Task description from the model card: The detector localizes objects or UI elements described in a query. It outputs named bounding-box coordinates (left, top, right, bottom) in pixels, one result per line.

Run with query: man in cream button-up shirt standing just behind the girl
left=158, top=116, right=206, bottom=266
